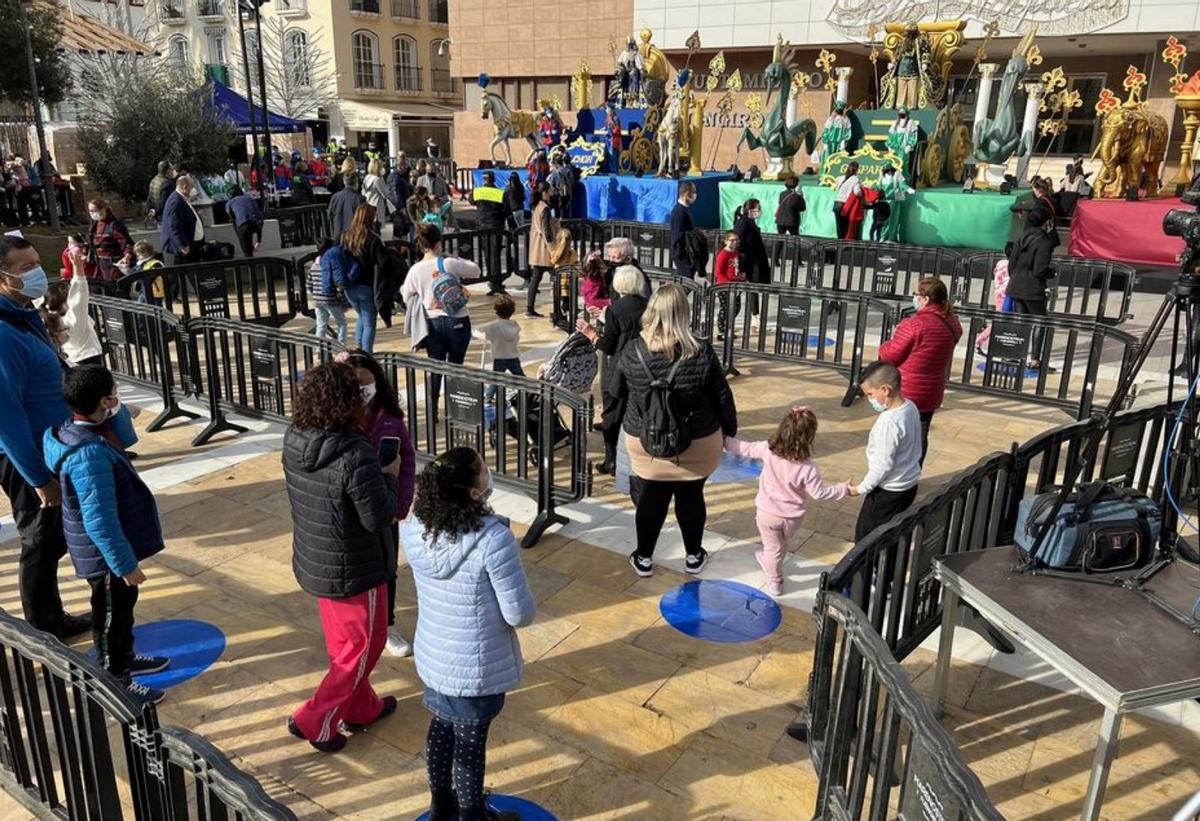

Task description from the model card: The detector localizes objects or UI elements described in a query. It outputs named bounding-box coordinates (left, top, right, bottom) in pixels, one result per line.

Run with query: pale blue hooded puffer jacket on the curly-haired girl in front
left=400, top=516, right=536, bottom=696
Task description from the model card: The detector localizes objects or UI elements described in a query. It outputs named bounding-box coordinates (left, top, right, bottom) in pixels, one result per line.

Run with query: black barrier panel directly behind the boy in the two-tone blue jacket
left=88, top=296, right=197, bottom=432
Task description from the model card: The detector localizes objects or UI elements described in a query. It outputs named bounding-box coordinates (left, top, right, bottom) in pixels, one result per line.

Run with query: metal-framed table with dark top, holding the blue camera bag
left=932, top=547, right=1200, bottom=821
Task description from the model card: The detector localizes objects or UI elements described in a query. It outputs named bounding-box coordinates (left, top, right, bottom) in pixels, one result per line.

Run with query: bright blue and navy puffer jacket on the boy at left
left=42, top=407, right=163, bottom=579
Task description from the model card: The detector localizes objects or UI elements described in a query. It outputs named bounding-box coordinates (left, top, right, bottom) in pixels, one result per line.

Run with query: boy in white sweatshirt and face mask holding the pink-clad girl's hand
left=850, top=362, right=920, bottom=541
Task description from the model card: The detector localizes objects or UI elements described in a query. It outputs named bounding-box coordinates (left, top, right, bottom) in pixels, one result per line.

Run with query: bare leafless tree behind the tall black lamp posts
left=230, top=17, right=337, bottom=120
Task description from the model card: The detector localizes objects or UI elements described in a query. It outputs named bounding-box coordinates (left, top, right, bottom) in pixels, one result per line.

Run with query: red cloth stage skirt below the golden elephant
left=1069, top=197, right=1192, bottom=268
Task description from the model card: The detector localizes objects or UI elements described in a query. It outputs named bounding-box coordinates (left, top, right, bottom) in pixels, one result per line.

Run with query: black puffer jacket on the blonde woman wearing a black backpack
left=613, top=337, right=738, bottom=439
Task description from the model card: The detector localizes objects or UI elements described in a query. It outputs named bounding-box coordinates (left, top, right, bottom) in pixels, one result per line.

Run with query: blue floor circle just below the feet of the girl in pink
left=659, top=581, right=784, bottom=643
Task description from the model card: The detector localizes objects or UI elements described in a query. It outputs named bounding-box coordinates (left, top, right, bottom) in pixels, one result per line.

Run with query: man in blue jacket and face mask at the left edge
left=0, top=236, right=91, bottom=639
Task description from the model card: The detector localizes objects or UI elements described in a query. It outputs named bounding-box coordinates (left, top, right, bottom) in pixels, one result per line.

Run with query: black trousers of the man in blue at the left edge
left=0, top=454, right=67, bottom=633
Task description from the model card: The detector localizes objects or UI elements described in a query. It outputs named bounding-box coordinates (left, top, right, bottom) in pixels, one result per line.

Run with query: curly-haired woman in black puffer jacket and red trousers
left=283, top=362, right=400, bottom=753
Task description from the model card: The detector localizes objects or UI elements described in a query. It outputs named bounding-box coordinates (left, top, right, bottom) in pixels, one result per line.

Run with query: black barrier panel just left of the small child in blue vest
left=116, top=257, right=298, bottom=328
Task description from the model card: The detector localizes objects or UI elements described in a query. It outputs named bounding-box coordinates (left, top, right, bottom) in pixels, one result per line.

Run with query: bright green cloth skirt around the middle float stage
left=715, top=181, right=1028, bottom=251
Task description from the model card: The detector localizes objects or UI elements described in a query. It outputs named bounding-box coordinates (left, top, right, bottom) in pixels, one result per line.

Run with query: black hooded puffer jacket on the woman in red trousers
left=283, top=427, right=398, bottom=599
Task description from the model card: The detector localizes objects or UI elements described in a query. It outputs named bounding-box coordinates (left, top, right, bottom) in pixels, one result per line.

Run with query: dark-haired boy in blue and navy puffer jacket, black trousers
left=42, top=365, right=170, bottom=705
